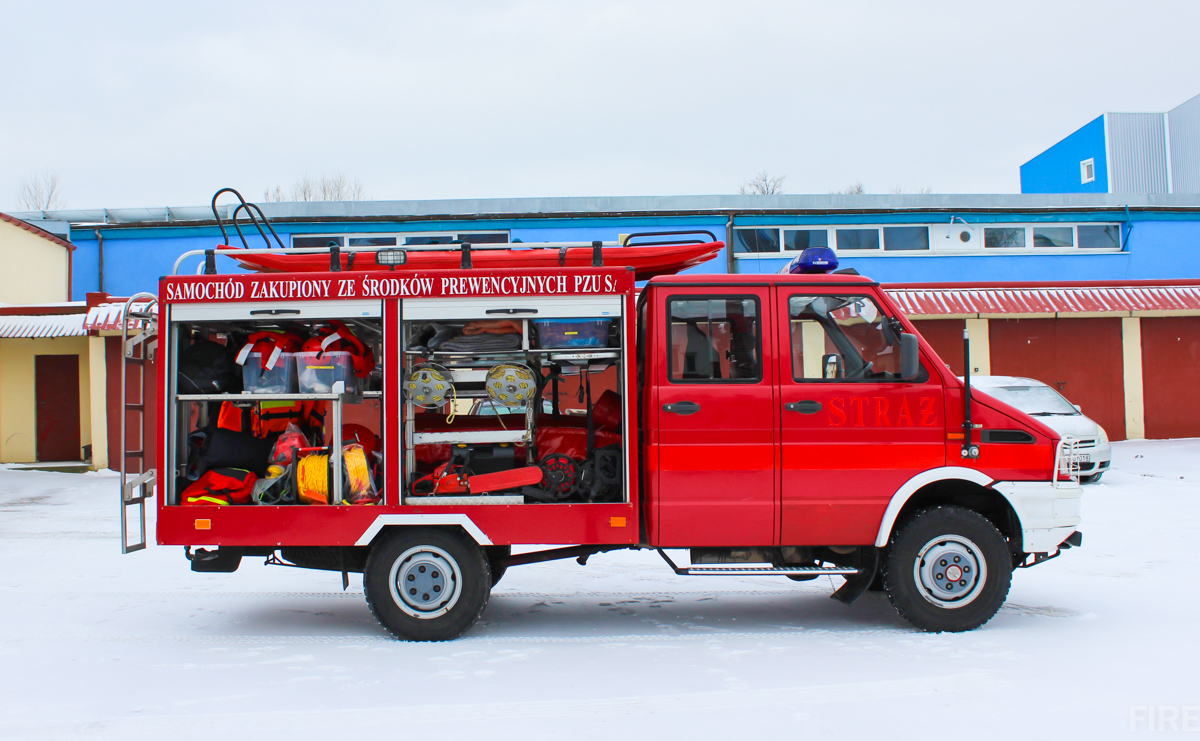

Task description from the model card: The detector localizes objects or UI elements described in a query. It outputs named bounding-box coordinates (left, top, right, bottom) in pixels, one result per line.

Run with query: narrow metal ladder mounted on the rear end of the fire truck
left=121, top=293, right=158, bottom=553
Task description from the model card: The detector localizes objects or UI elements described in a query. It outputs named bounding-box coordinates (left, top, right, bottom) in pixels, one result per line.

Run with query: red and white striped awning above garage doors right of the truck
left=884, top=285, right=1200, bottom=317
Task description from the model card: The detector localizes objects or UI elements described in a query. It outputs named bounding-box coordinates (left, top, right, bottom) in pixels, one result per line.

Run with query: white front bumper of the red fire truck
left=991, top=481, right=1084, bottom=553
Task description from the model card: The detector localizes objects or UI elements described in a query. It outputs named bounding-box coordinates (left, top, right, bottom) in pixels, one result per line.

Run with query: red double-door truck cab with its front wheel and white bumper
left=638, top=273, right=1080, bottom=629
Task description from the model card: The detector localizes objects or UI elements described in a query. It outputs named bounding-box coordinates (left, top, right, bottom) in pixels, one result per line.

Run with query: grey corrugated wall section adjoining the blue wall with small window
left=1105, top=113, right=1168, bottom=193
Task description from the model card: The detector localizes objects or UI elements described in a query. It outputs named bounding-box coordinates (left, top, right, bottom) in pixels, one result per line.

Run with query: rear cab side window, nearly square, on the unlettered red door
left=667, top=296, right=762, bottom=384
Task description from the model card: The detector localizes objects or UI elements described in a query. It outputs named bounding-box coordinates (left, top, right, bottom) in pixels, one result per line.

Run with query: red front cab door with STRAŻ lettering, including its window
left=774, top=287, right=946, bottom=546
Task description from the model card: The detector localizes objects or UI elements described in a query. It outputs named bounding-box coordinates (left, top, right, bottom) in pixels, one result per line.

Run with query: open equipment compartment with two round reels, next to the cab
left=400, top=295, right=629, bottom=505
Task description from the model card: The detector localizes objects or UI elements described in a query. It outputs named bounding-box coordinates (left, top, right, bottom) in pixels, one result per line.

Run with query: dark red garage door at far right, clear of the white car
left=1141, top=317, right=1200, bottom=439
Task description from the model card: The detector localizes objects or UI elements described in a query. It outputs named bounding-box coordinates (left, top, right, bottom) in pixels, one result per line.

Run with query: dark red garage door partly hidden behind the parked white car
left=988, top=318, right=1123, bottom=440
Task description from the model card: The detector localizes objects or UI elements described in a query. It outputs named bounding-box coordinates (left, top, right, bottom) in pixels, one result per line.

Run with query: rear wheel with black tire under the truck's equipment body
left=362, top=529, right=492, bottom=640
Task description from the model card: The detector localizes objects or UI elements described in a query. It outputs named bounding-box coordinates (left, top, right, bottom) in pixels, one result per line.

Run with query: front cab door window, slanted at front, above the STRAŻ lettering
left=787, top=295, right=902, bottom=382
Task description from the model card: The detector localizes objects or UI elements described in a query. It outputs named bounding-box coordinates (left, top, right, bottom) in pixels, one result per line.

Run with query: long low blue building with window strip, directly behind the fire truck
left=14, top=193, right=1200, bottom=299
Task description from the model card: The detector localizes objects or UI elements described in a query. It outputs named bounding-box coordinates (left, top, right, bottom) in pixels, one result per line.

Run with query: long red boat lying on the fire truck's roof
left=217, top=241, right=725, bottom=281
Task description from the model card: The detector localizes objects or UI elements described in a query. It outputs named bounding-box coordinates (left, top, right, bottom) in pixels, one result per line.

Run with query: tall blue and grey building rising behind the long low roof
left=1021, top=96, right=1200, bottom=194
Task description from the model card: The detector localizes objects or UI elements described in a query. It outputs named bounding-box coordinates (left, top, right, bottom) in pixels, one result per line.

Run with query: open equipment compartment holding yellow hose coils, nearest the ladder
left=163, top=301, right=385, bottom=506
